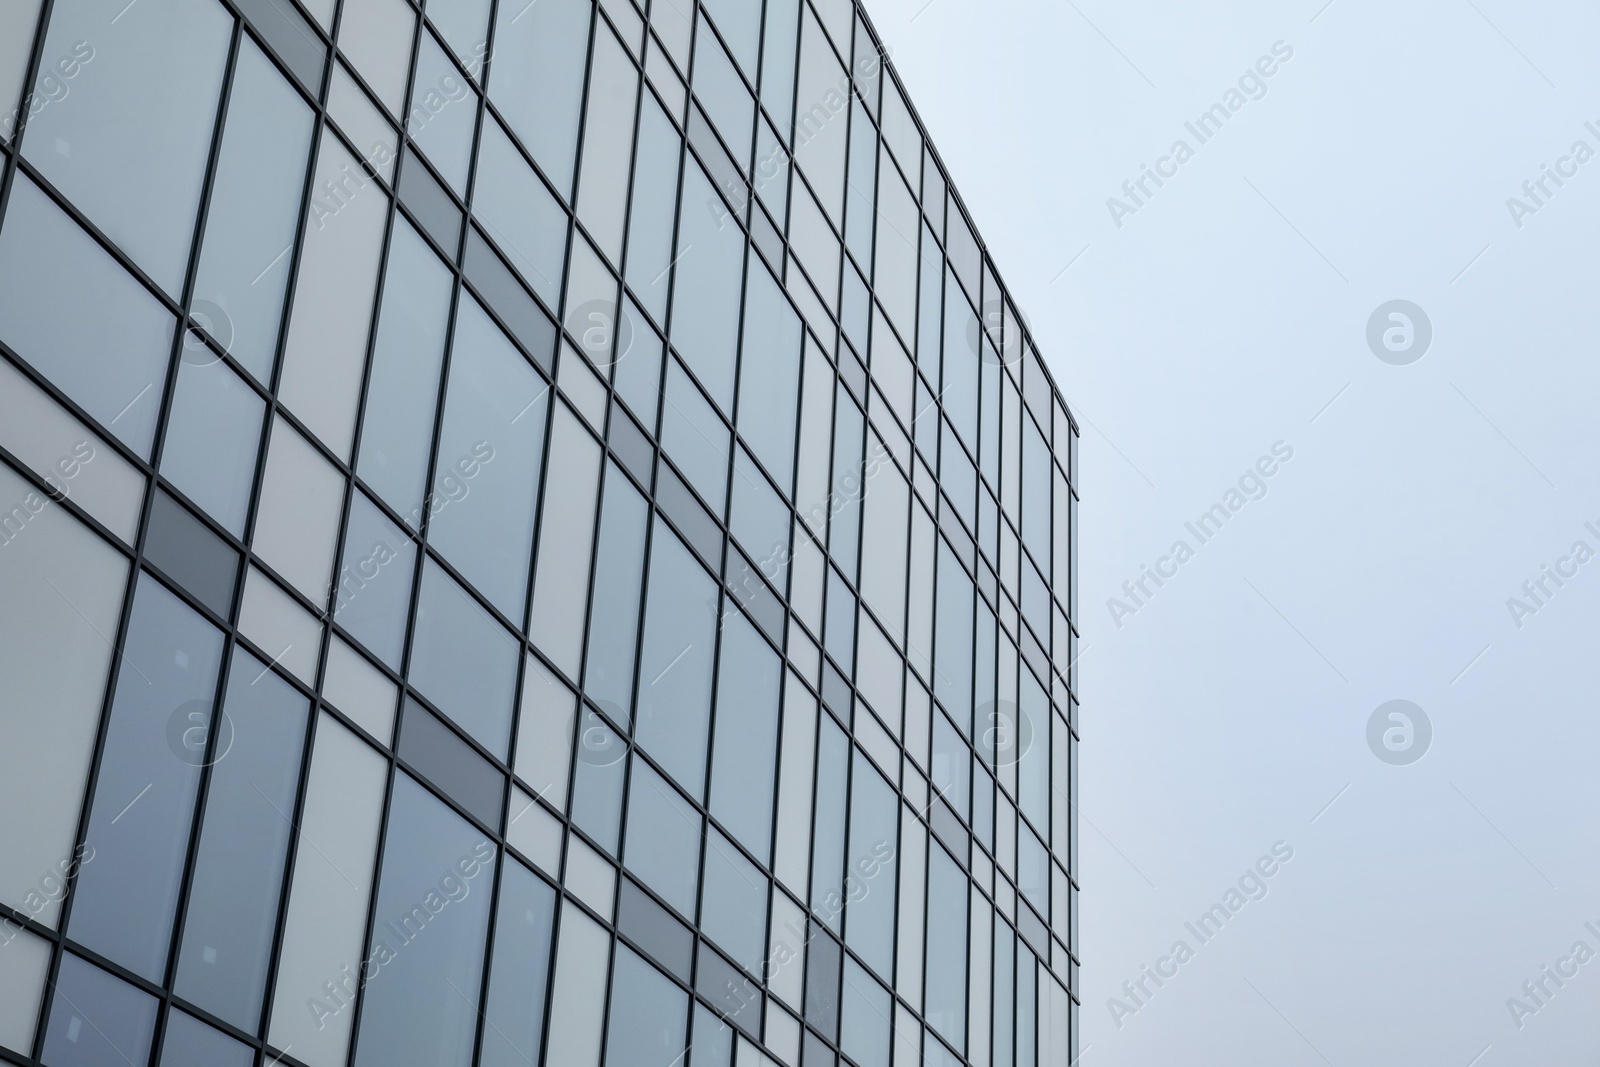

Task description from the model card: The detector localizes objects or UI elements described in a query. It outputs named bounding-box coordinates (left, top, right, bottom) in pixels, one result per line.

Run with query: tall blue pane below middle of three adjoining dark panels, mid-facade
left=637, top=520, right=717, bottom=797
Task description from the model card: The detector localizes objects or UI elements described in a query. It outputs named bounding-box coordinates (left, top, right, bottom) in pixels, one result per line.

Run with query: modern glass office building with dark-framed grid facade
left=0, top=0, right=1078, bottom=1067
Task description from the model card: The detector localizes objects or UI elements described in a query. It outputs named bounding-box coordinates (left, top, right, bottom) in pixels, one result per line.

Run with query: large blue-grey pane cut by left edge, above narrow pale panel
left=0, top=174, right=173, bottom=456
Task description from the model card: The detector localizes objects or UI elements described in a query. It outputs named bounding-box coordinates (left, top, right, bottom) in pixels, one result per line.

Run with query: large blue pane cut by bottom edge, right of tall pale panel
left=355, top=774, right=496, bottom=1067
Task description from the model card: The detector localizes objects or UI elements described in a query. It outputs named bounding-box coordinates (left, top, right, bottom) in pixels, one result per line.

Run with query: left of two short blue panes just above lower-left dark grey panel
left=333, top=493, right=416, bottom=670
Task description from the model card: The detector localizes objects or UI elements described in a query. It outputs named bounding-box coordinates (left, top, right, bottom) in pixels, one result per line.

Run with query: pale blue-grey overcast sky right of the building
left=867, top=0, right=1600, bottom=1067
